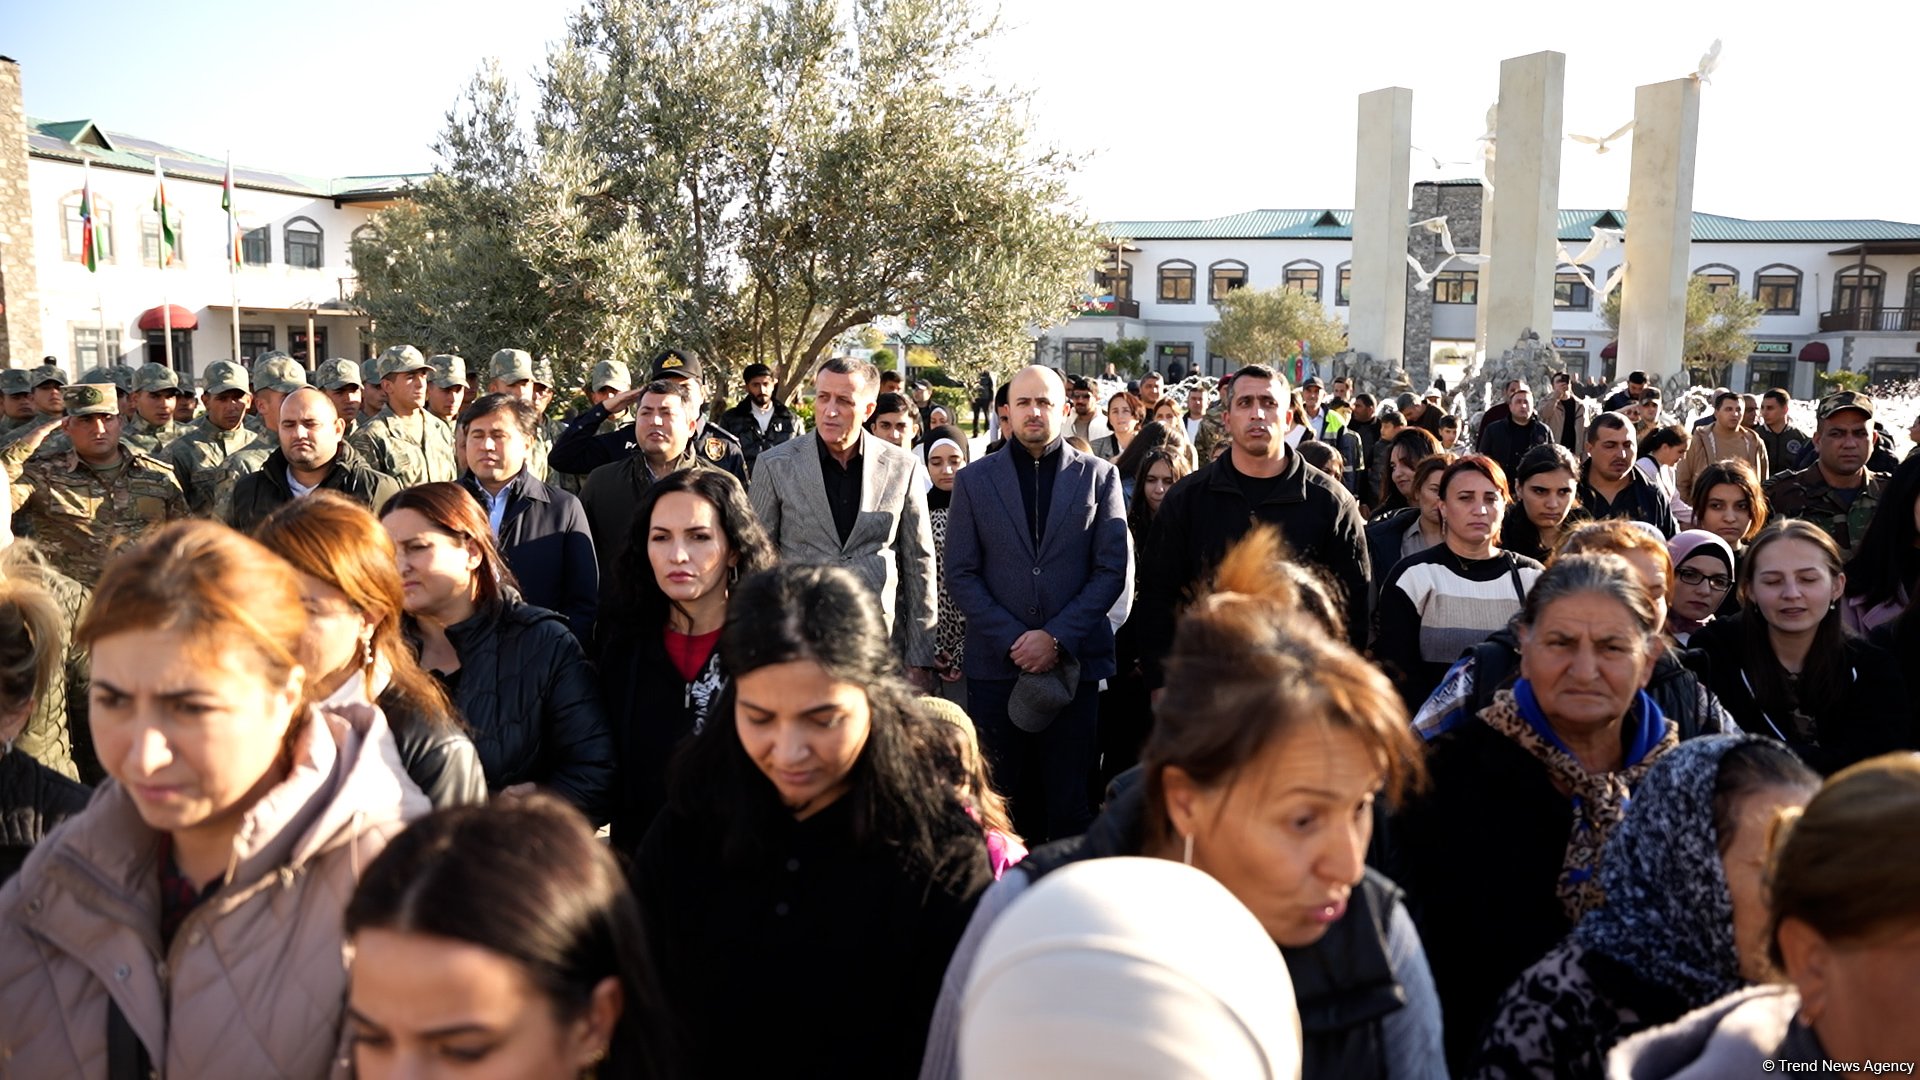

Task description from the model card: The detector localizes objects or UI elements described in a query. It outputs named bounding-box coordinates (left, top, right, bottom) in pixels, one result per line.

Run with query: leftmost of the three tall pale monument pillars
left=1334, top=86, right=1413, bottom=373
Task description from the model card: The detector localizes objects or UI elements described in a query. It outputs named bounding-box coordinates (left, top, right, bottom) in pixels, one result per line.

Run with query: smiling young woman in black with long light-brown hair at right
left=1688, top=519, right=1914, bottom=776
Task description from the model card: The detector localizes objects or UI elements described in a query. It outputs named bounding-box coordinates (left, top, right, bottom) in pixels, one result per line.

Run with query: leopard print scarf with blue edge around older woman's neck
left=1480, top=688, right=1680, bottom=922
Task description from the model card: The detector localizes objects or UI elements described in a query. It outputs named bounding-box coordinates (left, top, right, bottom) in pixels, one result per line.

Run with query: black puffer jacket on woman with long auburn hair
left=422, top=600, right=614, bottom=824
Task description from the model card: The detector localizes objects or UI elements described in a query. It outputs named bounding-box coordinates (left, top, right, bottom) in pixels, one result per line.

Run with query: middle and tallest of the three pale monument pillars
left=1480, top=52, right=1567, bottom=357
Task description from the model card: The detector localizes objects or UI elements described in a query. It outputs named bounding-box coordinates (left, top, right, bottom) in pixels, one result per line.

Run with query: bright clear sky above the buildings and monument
left=0, top=0, right=1920, bottom=221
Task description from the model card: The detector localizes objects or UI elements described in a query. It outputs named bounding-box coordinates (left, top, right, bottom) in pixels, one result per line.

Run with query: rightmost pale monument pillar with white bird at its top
left=1620, top=79, right=1699, bottom=388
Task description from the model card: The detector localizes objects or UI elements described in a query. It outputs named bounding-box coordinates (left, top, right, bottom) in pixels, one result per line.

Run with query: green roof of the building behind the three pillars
left=1102, top=197, right=1920, bottom=244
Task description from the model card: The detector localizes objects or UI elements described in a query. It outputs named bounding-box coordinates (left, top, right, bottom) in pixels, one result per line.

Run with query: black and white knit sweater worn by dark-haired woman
left=1373, top=544, right=1544, bottom=711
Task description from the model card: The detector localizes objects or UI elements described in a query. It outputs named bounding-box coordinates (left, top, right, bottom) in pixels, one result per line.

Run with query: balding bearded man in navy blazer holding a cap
left=947, top=367, right=1133, bottom=842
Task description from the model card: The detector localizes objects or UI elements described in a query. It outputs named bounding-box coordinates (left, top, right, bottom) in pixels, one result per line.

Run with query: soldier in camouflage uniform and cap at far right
left=1764, top=390, right=1905, bottom=559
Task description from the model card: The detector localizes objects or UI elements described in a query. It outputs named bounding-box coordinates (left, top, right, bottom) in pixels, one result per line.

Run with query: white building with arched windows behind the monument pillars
left=1037, top=184, right=1920, bottom=398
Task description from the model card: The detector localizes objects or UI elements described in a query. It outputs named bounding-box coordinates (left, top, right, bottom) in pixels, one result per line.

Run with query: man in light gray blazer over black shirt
left=747, top=357, right=937, bottom=690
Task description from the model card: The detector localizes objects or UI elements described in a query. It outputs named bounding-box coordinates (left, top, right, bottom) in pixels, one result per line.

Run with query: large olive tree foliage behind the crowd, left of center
left=355, top=0, right=1098, bottom=398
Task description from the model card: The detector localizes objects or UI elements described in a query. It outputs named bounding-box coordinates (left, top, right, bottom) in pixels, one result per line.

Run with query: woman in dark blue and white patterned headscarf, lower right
left=1467, top=736, right=1820, bottom=1080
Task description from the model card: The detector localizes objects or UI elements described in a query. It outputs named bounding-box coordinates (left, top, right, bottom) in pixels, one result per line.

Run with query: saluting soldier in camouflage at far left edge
left=0, top=382, right=186, bottom=586
